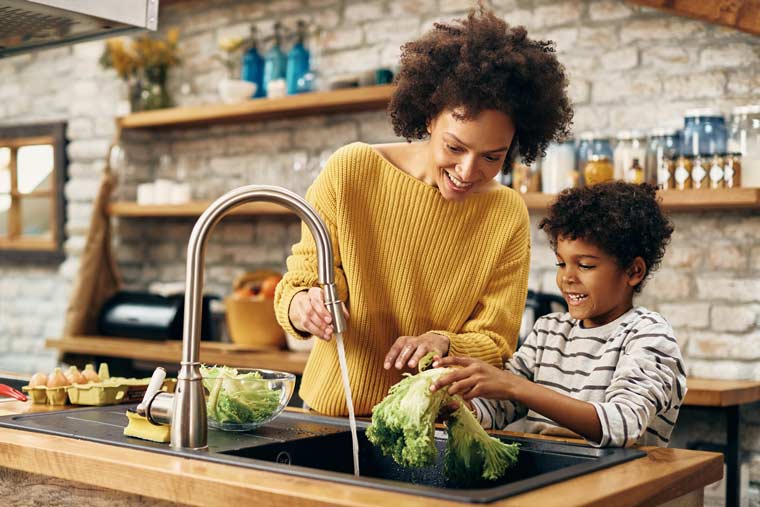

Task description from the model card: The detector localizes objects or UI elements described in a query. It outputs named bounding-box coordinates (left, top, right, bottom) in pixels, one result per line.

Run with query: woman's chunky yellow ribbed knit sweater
left=275, top=143, right=530, bottom=415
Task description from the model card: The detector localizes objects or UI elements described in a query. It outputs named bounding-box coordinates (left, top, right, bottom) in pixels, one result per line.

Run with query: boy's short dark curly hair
left=538, top=181, right=673, bottom=292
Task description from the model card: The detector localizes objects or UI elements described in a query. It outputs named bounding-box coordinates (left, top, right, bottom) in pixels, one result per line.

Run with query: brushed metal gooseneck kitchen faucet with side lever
left=137, top=185, right=346, bottom=449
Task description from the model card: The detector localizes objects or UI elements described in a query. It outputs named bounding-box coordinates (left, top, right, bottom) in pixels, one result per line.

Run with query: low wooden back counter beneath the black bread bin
left=45, top=336, right=309, bottom=375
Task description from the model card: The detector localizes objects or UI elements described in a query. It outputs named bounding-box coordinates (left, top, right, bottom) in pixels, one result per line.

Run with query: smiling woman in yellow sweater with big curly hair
left=275, top=8, right=572, bottom=415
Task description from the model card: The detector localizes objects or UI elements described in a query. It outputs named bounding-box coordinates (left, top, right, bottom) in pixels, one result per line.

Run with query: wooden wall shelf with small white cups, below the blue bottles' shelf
left=108, top=201, right=293, bottom=218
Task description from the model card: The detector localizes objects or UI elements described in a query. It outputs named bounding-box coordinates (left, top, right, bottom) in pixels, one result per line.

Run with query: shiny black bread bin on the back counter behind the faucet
left=98, top=291, right=218, bottom=341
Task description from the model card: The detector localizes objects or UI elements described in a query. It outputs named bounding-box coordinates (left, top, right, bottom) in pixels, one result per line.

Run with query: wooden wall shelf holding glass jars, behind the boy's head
left=522, top=188, right=760, bottom=211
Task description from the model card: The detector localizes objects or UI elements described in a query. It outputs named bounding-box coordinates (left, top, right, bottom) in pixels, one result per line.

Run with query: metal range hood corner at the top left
left=0, top=0, right=158, bottom=57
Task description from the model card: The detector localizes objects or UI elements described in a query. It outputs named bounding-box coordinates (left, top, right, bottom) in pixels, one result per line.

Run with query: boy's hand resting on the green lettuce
left=430, top=357, right=524, bottom=400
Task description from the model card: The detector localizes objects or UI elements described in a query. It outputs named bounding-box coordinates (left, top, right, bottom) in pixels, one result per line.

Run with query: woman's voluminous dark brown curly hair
left=388, top=5, right=573, bottom=172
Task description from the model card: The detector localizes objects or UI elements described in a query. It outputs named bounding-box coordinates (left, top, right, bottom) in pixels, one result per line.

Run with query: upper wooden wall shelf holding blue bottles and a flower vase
left=118, top=85, right=394, bottom=129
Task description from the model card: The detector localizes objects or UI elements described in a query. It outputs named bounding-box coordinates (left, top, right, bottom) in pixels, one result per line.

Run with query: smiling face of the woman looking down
left=429, top=109, right=515, bottom=201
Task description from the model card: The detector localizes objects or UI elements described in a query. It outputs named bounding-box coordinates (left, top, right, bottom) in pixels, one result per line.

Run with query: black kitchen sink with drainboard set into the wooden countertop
left=0, top=405, right=644, bottom=503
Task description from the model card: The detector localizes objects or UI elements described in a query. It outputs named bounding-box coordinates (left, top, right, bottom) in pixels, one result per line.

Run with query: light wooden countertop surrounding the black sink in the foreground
left=0, top=402, right=723, bottom=507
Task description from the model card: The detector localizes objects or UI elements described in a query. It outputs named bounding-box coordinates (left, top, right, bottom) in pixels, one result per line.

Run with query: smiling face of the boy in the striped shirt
left=555, top=236, right=645, bottom=328
